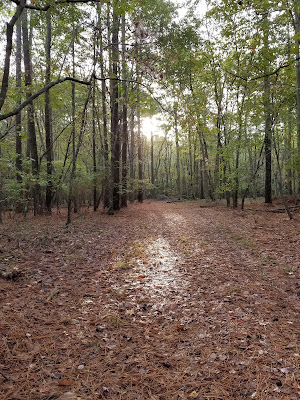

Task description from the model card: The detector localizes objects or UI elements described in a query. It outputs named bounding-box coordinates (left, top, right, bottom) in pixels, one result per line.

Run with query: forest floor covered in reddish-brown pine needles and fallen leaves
left=0, top=202, right=300, bottom=400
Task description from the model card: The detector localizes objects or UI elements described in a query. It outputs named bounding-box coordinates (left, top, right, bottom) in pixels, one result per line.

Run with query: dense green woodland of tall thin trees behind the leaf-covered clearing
left=0, top=0, right=300, bottom=222
